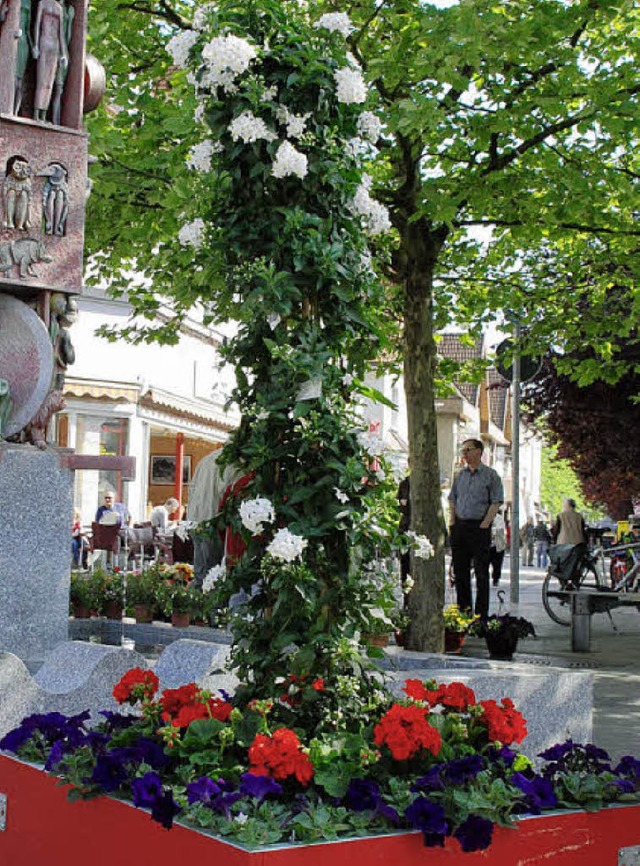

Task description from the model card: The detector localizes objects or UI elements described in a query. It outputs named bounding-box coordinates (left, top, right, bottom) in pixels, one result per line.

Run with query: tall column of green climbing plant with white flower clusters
left=164, top=0, right=398, bottom=694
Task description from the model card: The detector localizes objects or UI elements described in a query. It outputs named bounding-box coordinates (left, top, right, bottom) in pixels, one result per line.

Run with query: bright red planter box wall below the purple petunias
left=0, top=755, right=640, bottom=866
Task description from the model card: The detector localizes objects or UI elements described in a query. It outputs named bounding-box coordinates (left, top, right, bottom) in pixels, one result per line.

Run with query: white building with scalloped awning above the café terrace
left=57, top=288, right=239, bottom=523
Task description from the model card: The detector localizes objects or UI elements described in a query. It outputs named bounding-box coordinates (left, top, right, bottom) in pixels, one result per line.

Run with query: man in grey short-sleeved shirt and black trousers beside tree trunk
left=449, top=439, right=504, bottom=619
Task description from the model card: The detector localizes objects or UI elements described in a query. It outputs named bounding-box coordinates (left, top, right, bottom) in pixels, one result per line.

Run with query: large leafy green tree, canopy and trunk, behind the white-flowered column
left=90, top=0, right=638, bottom=649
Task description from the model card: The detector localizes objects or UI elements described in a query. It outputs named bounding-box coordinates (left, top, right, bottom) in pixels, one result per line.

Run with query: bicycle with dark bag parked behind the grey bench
left=542, top=544, right=640, bottom=626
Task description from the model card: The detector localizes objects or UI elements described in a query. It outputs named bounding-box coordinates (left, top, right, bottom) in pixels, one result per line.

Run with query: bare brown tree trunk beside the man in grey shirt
left=402, top=214, right=445, bottom=652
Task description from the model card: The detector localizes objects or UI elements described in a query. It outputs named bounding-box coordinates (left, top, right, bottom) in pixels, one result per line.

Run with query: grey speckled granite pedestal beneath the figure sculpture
left=0, top=442, right=73, bottom=667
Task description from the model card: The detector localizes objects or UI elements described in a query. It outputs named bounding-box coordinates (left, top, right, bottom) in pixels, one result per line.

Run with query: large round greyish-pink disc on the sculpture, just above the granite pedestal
left=0, top=294, right=53, bottom=436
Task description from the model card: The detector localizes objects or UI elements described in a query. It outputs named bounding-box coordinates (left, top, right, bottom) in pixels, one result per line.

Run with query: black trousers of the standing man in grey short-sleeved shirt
left=451, top=520, right=491, bottom=617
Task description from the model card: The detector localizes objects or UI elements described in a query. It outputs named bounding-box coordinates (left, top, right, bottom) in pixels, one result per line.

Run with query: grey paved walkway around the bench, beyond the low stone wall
left=447, top=558, right=640, bottom=758
